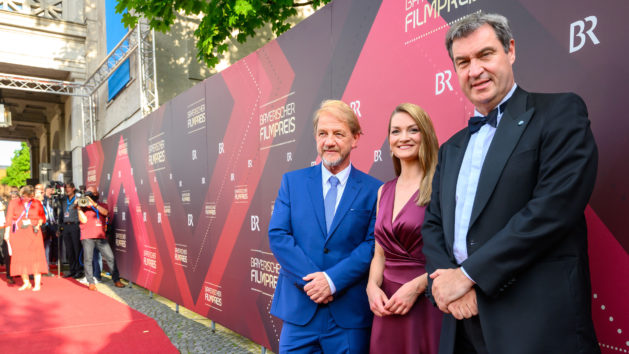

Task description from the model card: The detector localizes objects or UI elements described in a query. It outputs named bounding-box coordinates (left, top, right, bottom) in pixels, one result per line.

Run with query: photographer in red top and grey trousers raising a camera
left=78, top=187, right=124, bottom=290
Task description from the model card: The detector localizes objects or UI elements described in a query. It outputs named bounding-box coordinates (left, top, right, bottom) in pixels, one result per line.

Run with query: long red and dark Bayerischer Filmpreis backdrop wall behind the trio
left=83, top=0, right=629, bottom=353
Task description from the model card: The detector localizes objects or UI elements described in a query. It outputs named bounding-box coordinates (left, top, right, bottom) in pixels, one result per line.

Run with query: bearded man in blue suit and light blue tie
left=269, top=100, right=382, bottom=353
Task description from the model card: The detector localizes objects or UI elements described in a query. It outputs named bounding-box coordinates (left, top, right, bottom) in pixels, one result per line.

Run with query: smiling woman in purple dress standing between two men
left=367, top=103, right=443, bottom=354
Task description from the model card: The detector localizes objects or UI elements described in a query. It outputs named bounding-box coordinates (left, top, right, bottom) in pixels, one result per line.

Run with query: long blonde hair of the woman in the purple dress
left=389, top=103, right=439, bottom=206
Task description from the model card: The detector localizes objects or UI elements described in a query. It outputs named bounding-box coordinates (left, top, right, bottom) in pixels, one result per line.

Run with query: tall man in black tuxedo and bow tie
left=422, top=13, right=600, bottom=354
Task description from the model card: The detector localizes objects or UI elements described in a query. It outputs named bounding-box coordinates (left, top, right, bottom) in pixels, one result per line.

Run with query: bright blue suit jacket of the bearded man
left=269, top=164, right=382, bottom=328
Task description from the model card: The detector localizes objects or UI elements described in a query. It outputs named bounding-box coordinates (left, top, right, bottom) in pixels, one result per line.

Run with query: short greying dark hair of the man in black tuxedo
left=446, top=12, right=513, bottom=60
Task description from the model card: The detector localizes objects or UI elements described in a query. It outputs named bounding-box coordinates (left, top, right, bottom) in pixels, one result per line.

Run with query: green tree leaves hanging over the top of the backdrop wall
left=116, top=0, right=331, bottom=67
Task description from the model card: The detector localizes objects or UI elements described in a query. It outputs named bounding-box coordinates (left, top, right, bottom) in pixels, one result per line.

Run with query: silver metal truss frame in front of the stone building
left=0, top=19, right=158, bottom=146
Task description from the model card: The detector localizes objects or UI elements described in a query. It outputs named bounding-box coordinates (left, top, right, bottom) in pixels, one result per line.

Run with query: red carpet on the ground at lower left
left=0, top=274, right=178, bottom=353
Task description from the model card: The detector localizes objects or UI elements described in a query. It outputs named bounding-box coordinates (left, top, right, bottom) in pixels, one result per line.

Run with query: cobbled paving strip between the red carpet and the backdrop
left=96, top=278, right=272, bottom=354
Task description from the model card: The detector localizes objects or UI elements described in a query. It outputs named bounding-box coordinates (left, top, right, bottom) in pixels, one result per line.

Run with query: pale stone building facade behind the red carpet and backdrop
left=0, top=0, right=313, bottom=185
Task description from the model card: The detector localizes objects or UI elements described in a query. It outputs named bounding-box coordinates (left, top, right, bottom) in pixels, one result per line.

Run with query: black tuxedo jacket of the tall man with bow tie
left=422, top=88, right=600, bottom=354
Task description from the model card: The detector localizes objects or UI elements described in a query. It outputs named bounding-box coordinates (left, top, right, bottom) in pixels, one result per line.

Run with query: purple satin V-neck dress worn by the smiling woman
left=370, top=178, right=443, bottom=354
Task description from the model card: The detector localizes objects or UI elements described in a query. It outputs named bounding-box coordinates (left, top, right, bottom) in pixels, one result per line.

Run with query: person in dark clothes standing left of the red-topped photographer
left=59, top=182, right=83, bottom=279
